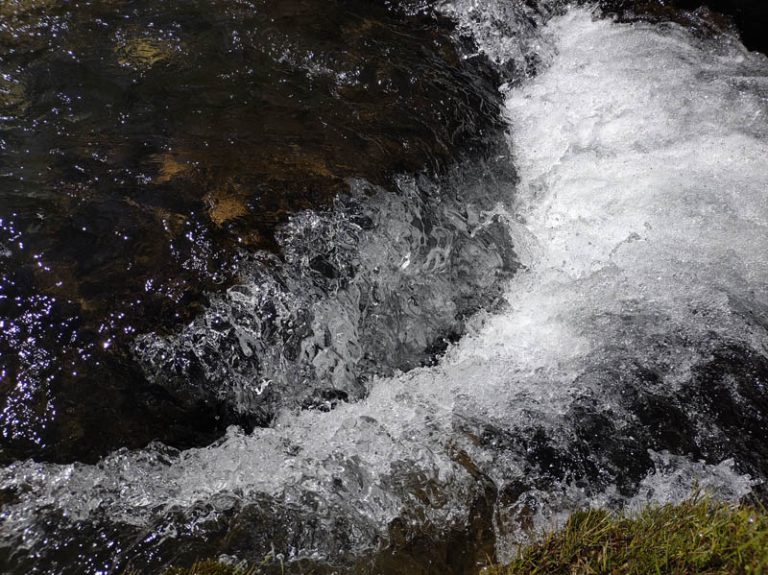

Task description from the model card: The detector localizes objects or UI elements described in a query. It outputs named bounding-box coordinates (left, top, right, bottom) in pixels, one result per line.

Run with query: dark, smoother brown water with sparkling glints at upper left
left=0, top=0, right=500, bottom=461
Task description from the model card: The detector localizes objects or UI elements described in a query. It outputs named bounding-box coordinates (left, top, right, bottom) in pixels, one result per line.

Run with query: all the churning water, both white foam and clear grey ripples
left=0, top=3, right=768, bottom=573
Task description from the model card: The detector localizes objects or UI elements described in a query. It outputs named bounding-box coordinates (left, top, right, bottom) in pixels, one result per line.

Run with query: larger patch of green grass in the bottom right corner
left=488, top=498, right=768, bottom=575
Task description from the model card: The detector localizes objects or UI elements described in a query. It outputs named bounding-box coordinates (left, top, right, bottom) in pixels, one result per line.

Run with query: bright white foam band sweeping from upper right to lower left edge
left=0, top=9, right=768, bottom=572
